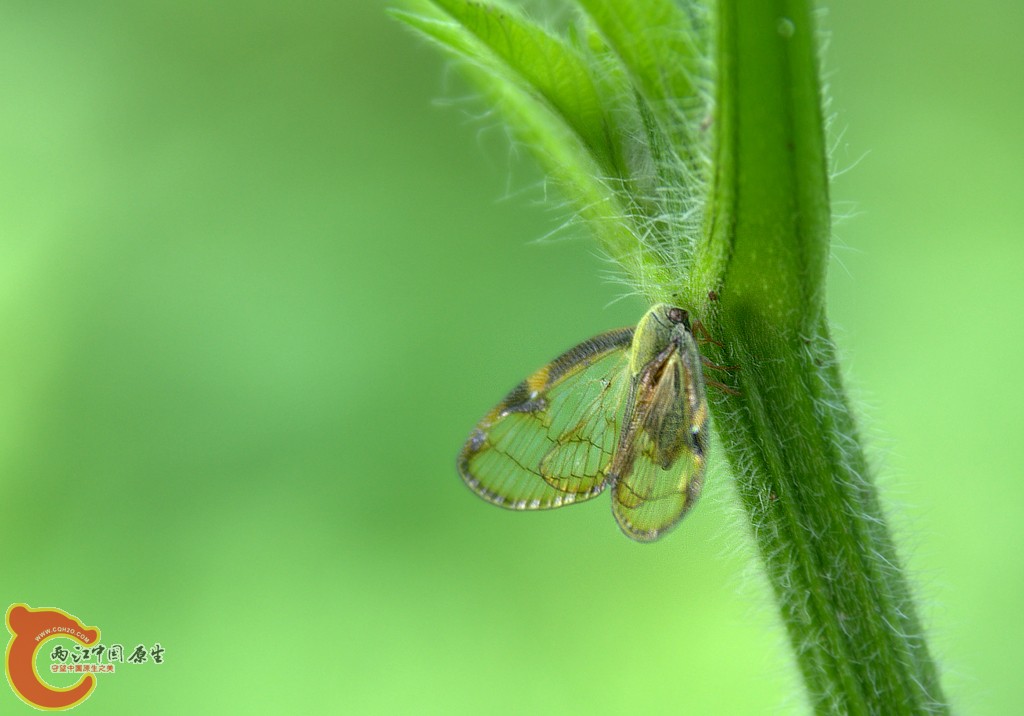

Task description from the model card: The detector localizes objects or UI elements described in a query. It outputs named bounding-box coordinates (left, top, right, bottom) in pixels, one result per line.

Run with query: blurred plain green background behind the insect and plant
left=0, top=0, right=1024, bottom=714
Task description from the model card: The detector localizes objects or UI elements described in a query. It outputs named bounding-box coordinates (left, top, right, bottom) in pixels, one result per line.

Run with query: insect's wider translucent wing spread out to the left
left=459, top=328, right=633, bottom=510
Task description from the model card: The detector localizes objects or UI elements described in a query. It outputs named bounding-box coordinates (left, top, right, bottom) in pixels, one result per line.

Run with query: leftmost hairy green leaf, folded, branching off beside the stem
left=394, top=0, right=670, bottom=283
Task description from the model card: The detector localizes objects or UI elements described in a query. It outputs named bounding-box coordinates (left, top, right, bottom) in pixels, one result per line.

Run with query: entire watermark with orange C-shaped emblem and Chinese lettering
left=4, top=604, right=165, bottom=711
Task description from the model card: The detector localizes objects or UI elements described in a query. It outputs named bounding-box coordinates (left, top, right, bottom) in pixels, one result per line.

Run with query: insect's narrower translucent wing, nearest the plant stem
left=610, top=332, right=708, bottom=542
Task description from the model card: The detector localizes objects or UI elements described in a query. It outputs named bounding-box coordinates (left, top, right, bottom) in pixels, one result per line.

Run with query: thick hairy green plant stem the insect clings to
left=689, top=0, right=946, bottom=714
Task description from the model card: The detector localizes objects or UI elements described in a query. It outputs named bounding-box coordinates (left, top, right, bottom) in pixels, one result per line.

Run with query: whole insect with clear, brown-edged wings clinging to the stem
left=458, top=303, right=708, bottom=542
